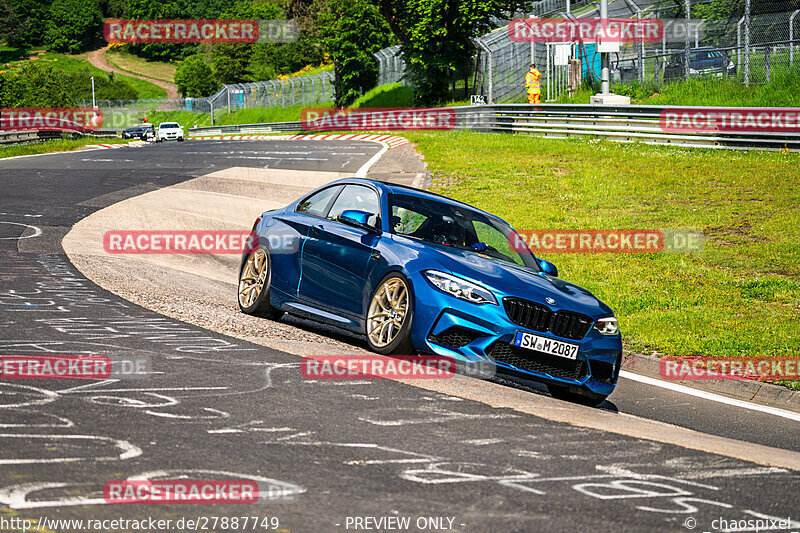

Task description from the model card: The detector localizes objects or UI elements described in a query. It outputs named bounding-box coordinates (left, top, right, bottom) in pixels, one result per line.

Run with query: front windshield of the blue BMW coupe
left=389, top=194, right=539, bottom=270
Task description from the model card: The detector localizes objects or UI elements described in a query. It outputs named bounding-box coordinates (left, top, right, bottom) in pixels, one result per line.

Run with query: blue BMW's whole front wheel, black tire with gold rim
left=366, top=272, right=414, bottom=355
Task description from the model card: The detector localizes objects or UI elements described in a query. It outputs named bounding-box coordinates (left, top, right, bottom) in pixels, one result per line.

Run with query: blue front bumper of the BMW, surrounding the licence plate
left=411, top=274, right=622, bottom=395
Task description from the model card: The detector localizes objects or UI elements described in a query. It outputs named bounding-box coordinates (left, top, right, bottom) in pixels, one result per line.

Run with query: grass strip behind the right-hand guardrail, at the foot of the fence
left=557, top=73, right=800, bottom=107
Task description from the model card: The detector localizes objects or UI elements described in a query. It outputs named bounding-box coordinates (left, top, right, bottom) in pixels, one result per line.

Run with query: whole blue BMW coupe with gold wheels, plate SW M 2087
left=238, top=178, right=622, bottom=405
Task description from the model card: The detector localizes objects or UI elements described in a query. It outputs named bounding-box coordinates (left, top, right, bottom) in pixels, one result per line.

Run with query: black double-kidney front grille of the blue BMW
left=503, top=298, right=593, bottom=340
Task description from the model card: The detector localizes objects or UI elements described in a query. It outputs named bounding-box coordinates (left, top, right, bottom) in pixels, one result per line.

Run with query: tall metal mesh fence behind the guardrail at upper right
left=375, top=0, right=800, bottom=103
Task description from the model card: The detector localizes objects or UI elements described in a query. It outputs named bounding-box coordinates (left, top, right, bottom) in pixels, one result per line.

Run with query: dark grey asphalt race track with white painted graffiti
left=0, top=141, right=800, bottom=532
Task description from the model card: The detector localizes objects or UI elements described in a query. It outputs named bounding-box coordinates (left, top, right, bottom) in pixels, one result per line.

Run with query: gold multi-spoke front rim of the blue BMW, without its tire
left=367, top=278, right=409, bottom=348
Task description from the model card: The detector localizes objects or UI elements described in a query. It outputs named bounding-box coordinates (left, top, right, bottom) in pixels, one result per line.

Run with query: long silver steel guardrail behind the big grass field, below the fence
left=189, top=104, right=800, bottom=150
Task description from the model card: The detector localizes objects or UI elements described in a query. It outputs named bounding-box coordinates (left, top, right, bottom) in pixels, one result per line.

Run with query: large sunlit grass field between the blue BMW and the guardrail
left=403, top=132, right=800, bottom=386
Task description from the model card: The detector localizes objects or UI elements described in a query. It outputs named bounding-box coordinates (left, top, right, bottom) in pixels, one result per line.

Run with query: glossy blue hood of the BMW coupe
left=406, top=239, right=613, bottom=318
